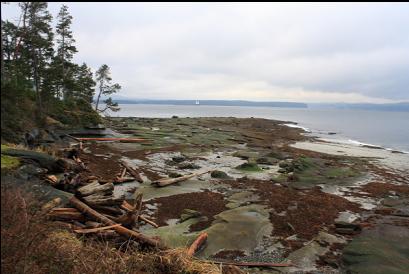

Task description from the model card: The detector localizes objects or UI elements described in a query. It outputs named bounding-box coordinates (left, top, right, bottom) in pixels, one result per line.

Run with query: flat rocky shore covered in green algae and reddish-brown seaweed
left=2, top=117, right=409, bottom=273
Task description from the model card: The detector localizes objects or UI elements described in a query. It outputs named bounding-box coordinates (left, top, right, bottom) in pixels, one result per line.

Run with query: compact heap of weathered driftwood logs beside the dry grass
left=48, top=174, right=162, bottom=248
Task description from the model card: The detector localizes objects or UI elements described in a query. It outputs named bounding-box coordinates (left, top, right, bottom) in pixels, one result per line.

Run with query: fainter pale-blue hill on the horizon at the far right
left=308, top=102, right=409, bottom=111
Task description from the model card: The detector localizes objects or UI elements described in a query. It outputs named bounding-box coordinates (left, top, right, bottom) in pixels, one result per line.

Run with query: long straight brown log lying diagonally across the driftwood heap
left=70, top=197, right=165, bottom=249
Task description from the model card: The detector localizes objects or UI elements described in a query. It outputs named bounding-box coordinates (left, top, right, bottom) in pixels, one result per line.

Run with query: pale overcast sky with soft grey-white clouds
left=2, top=2, right=409, bottom=103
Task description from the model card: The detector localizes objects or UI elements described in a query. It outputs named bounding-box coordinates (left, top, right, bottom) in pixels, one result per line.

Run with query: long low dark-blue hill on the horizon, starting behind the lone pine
left=111, top=99, right=308, bottom=108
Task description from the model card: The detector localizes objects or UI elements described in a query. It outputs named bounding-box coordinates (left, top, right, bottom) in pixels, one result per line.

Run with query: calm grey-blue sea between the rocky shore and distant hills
left=111, top=104, right=409, bottom=152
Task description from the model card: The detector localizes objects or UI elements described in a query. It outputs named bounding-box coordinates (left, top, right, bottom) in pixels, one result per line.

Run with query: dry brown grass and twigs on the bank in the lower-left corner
left=1, top=186, right=221, bottom=274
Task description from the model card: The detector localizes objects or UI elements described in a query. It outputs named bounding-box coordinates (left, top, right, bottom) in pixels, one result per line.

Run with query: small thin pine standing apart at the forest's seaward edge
left=95, top=65, right=121, bottom=113
